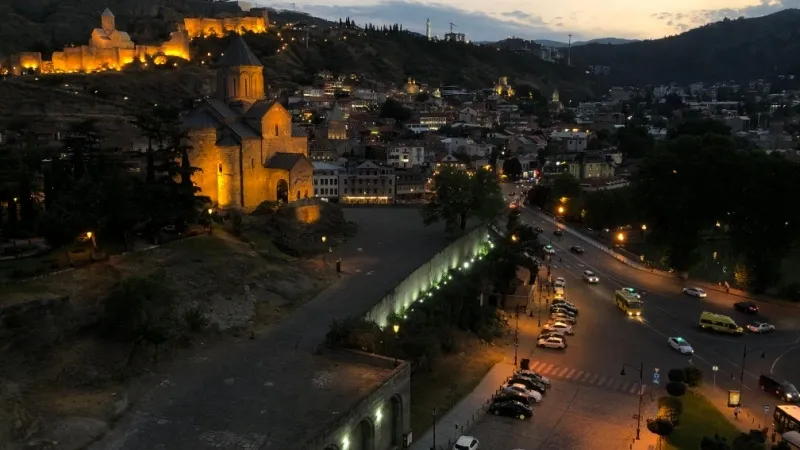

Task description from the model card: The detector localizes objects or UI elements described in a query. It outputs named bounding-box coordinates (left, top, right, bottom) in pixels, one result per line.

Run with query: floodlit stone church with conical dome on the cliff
left=184, top=35, right=314, bottom=210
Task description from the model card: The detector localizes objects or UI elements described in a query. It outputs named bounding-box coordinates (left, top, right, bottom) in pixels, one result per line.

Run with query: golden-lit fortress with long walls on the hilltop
left=11, top=8, right=269, bottom=75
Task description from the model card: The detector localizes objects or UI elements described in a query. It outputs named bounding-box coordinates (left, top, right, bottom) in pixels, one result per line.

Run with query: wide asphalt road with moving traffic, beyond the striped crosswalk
left=504, top=185, right=800, bottom=414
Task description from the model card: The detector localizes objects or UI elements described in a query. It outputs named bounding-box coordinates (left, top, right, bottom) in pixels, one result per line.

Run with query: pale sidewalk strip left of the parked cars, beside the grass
left=410, top=361, right=514, bottom=450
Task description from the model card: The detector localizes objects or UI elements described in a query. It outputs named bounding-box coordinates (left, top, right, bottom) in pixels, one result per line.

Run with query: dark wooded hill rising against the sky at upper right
left=572, top=9, right=800, bottom=84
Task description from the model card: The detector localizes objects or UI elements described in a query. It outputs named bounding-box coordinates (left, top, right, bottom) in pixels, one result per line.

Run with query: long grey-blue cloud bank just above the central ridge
left=271, top=0, right=587, bottom=41
